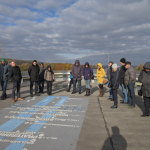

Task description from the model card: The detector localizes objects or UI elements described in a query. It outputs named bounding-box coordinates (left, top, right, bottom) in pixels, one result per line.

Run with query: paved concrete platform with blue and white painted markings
left=0, top=82, right=150, bottom=150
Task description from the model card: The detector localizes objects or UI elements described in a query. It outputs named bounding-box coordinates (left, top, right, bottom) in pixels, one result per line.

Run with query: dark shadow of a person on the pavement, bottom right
left=101, top=126, right=127, bottom=150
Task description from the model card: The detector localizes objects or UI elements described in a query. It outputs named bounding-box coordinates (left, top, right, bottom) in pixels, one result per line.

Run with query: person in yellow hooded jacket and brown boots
left=97, top=63, right=106, bottom=97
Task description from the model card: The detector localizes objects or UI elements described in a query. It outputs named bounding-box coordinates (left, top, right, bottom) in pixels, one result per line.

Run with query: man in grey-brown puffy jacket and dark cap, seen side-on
left=124, top=61, right=136, bottom=108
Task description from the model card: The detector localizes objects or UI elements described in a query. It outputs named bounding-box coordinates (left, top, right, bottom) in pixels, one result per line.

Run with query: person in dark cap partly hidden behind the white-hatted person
left=107, top=61, right=114, bottom=101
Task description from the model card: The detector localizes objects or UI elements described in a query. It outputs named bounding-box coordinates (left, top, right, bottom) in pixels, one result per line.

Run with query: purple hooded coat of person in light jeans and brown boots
left=83, top=62, right=93, bottom=80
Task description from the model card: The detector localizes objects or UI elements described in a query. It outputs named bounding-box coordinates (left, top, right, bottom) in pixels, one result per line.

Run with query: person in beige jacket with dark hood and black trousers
left=44, top=66, right=54, bottom=95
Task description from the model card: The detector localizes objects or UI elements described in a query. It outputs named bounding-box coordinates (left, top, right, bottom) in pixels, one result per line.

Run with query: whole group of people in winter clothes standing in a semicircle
left=0, top=58, right=150, bottom=117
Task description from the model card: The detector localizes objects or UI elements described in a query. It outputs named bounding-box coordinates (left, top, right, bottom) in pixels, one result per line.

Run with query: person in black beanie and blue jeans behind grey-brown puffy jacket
left=120, top=58, right=128, bottom=104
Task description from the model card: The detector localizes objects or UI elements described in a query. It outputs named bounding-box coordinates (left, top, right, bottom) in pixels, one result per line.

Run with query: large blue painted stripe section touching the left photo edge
left=0, top=119, right=25, bottom=132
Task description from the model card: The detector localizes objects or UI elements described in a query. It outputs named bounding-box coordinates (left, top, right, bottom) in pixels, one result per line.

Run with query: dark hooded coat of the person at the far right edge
left=138, top=62, right=150, bottom=97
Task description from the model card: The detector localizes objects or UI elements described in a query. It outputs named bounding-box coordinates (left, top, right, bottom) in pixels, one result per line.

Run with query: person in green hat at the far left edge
left=0, top=58, right=10, bottom=100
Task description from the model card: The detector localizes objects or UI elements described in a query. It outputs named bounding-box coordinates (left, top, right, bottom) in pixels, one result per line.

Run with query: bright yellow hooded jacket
left=97, top=63, right=106, bottom=83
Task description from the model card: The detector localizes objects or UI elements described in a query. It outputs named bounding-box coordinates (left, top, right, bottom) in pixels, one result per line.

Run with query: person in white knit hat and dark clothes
left=111, top=64, right=120, bottom=109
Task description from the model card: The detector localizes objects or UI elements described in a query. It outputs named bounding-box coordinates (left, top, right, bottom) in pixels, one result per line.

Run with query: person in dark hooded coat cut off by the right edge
left=138, top=62, right=150, bottom=117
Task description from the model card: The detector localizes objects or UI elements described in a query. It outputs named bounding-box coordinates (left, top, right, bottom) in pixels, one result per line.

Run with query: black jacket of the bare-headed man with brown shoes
left=9, top=66, right=22, bottom=83
